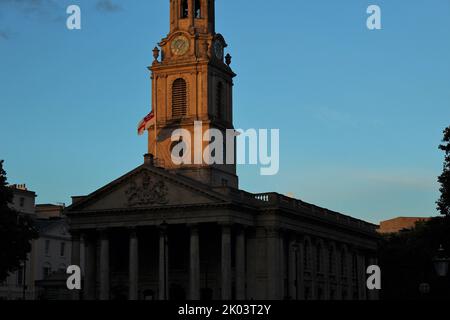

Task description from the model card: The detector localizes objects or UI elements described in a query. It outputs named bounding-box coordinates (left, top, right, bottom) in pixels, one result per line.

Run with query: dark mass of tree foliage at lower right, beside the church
left=379, top=216, right=450, bottom=300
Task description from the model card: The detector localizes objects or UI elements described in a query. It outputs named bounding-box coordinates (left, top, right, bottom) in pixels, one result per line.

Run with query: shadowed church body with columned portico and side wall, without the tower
left=67, top=156, right=377, bottom=300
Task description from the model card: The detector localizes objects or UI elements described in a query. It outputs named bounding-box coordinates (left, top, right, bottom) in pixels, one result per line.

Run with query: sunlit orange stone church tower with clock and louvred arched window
left=148, top=0, right=238, bottom=188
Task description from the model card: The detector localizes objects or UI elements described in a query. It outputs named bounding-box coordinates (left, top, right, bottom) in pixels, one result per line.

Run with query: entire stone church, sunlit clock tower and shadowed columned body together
left=66, top=0, right=378, bottom=300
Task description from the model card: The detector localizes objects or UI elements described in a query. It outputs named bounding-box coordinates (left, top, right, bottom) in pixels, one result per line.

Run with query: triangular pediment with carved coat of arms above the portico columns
left=68, top=165, right=226, bottom=212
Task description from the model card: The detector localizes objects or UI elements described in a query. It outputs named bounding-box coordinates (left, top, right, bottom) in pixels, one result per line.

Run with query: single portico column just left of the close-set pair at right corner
left=189, top=224, right=200, bottom=300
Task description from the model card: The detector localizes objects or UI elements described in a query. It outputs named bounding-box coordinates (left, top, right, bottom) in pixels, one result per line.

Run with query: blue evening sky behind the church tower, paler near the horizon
left=0, top=0, right=450, bottom=222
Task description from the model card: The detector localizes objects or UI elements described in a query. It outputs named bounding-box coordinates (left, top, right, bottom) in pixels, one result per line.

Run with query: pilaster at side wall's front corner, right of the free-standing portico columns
left=266, top=228, right=283, bottom=300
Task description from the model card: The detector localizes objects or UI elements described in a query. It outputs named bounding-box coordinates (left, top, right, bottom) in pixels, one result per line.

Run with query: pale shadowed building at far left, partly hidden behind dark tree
left=0, top=184, right=72, bottom=300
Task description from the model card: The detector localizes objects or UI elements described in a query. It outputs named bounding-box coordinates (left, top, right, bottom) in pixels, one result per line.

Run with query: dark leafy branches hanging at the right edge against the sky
left=437, top=127, right=450, bottom=216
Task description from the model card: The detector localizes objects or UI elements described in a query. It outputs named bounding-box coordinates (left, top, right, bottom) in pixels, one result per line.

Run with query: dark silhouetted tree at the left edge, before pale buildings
left=0, top=160, right=38, bottom=282
